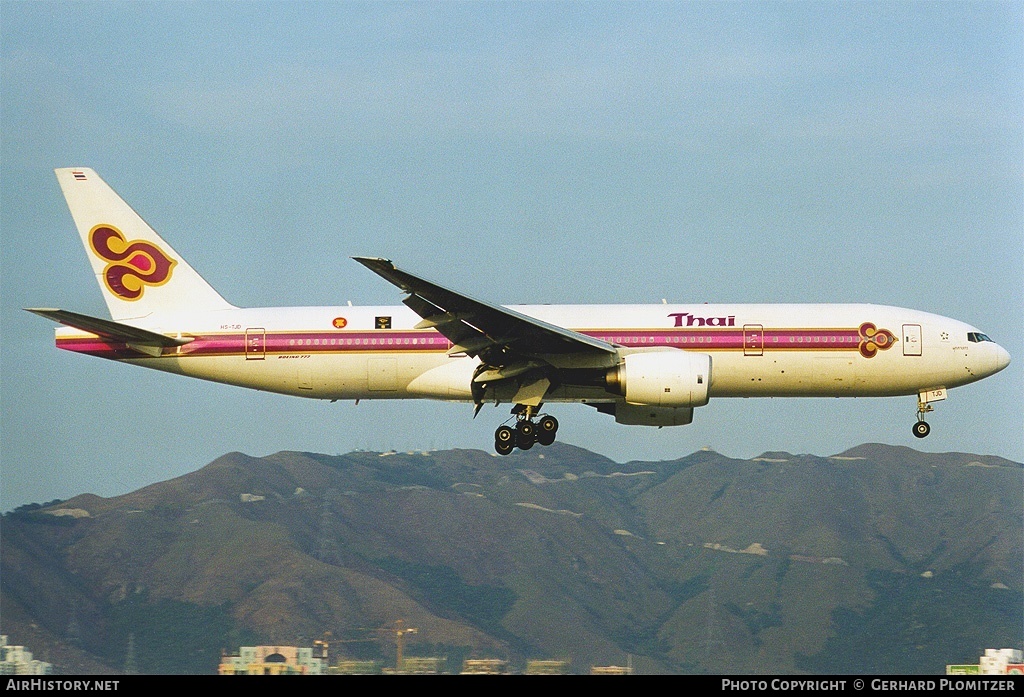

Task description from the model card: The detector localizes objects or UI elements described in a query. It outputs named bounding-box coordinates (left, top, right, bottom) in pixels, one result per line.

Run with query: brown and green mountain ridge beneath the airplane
left=0, top=443, right=1024, bottom=672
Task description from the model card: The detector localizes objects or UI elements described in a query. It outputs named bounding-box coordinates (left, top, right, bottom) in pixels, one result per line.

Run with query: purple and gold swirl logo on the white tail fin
left=89, top=224, right=178, bottom=301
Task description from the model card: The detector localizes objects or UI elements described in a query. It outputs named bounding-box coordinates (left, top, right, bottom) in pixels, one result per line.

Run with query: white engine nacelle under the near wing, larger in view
left=605, top=351, right=711, bottom=407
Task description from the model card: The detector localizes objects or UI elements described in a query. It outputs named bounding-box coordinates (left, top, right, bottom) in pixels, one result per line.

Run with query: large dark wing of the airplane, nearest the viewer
left=353, top=257, right=617, bottom=365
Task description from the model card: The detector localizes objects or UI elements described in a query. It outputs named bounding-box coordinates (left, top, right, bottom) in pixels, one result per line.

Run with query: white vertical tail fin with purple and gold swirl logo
left=55, top=167, right=233, bottom=319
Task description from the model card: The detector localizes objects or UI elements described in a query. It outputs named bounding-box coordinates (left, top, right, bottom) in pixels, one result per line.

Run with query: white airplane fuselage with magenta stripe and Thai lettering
left=57, top=304, right=1009, bottom=403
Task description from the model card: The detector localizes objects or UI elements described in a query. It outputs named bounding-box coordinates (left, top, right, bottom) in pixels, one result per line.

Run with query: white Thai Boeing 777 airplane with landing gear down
left=26, top=167, right=1010, bottom=454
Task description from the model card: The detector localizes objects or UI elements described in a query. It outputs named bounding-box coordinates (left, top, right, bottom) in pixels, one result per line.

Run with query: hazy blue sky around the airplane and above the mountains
left=0, top=0, right=1024, bottom=510
